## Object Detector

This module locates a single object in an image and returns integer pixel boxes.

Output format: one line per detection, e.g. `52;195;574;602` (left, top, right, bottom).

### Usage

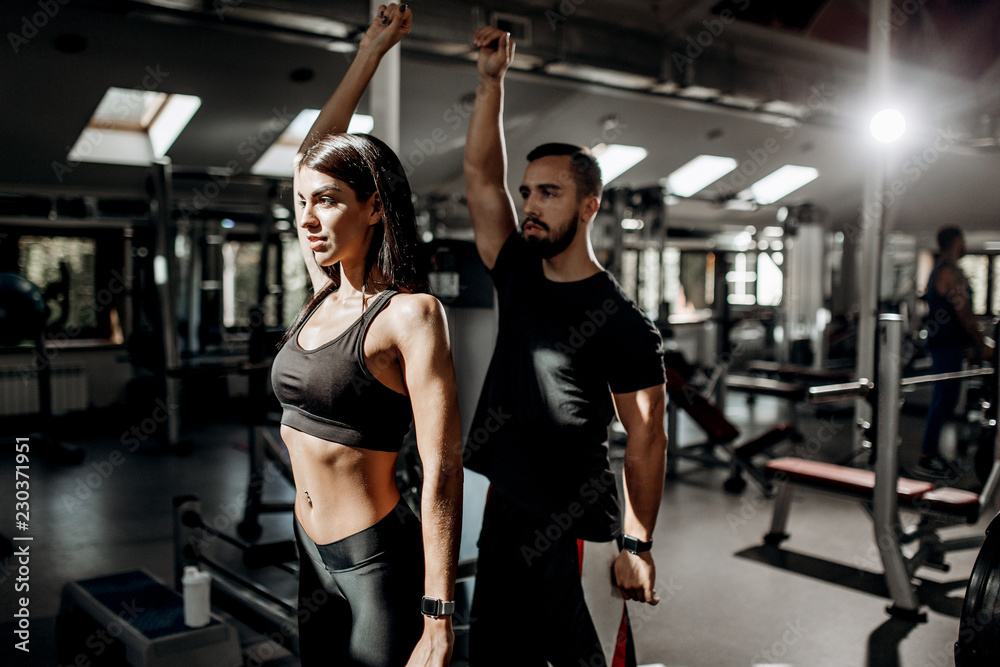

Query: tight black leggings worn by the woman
295;499;424;667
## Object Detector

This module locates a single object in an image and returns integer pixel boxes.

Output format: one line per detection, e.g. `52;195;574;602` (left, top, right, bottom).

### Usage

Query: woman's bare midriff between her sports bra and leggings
281;426;399;544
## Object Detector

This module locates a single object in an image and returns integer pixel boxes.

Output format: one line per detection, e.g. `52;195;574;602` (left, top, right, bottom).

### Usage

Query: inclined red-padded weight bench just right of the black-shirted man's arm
666;366;795;497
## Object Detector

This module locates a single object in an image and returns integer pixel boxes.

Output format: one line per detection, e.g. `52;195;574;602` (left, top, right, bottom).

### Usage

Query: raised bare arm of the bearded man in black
465;27;517;269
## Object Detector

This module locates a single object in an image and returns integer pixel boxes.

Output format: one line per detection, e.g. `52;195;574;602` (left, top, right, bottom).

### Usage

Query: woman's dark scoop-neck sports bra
271;290;413;452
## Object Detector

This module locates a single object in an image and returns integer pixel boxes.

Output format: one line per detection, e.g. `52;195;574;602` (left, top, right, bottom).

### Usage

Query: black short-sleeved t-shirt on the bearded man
465;232;664;541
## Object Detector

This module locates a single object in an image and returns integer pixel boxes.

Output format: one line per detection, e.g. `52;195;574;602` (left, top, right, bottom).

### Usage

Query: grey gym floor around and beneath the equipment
0;394;996;667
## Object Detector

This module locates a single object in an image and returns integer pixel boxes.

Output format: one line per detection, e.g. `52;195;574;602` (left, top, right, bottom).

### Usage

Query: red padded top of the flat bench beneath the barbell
765;457;979;523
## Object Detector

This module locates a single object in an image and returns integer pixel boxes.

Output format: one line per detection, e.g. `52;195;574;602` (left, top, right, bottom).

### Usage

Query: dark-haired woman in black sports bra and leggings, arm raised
272;5;462;667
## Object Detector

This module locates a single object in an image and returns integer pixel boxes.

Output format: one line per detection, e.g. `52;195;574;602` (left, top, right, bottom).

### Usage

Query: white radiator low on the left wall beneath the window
0;366;89;417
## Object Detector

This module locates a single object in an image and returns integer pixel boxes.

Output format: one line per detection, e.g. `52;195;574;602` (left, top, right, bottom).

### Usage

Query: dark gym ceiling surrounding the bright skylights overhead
0;0;1000;245
